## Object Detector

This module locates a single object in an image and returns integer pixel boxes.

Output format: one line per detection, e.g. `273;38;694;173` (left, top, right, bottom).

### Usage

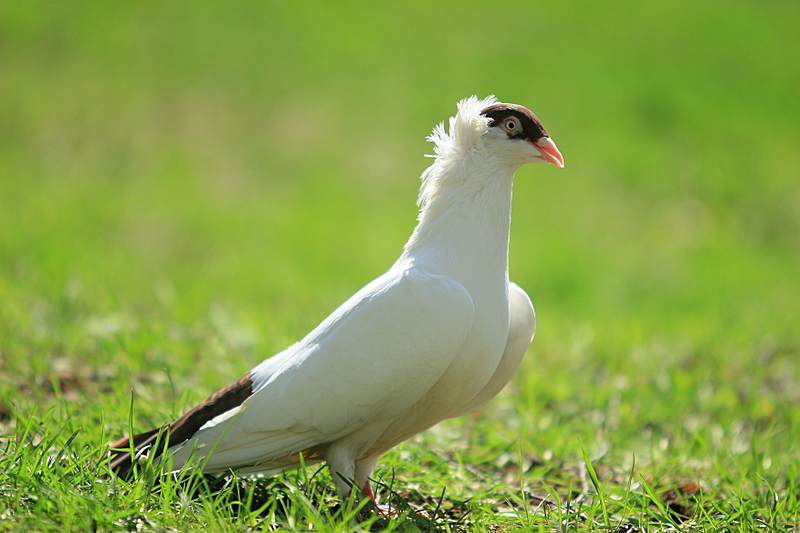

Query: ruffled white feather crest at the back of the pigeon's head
417;95;497;206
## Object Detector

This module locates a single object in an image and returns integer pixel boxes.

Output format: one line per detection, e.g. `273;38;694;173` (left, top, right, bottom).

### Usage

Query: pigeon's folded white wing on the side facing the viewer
169;269;474;471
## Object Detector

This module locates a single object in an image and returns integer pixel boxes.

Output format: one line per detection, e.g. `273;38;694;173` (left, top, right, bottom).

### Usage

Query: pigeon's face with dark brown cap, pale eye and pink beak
480;103;564;168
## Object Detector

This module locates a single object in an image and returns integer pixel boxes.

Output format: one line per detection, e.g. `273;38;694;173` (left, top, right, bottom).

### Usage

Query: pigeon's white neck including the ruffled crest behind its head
400;97;517;276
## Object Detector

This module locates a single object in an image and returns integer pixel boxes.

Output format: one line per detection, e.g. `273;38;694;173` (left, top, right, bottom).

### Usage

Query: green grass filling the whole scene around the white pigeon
0;0;800;533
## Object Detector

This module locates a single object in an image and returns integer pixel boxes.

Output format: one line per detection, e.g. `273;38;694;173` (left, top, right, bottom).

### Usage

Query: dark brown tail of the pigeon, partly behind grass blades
108;373;253;479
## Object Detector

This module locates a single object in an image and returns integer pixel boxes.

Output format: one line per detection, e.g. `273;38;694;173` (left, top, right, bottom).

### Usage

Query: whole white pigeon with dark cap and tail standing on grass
110;96;564;498
